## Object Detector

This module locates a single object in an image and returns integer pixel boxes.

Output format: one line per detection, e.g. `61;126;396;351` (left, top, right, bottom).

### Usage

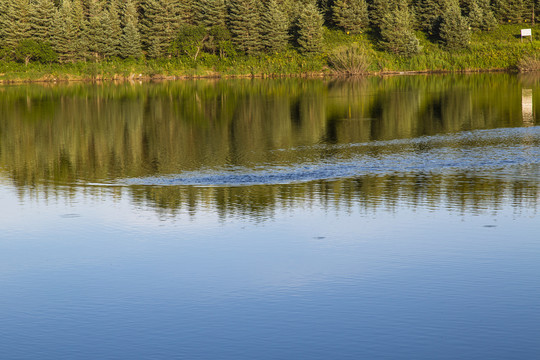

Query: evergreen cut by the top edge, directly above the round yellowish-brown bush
332;0;369;34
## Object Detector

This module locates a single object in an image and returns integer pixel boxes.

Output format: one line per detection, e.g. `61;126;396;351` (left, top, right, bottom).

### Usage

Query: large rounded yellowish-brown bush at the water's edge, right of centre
328;44;371;76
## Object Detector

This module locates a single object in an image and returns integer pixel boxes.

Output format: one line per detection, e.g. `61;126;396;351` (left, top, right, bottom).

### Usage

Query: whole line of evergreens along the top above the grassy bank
0;0;540;63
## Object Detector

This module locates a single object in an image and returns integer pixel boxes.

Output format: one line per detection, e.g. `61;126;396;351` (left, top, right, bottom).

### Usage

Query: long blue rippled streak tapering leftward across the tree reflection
121;127;540;186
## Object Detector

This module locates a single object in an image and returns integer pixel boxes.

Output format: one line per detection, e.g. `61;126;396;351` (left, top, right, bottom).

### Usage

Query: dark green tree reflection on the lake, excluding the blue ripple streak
0;74;540;217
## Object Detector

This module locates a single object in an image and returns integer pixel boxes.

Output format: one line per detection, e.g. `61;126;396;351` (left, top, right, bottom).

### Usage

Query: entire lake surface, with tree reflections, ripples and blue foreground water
0;74;540;360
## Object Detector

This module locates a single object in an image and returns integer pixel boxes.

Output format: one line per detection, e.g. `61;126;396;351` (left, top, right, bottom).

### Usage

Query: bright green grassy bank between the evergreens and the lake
0;24;540;82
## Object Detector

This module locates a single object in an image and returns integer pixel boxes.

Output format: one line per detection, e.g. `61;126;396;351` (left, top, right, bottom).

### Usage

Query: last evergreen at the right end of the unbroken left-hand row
297;3;324;53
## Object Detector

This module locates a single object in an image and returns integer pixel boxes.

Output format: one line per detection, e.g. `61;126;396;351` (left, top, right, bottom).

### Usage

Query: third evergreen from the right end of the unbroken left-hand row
228;0;261;55
